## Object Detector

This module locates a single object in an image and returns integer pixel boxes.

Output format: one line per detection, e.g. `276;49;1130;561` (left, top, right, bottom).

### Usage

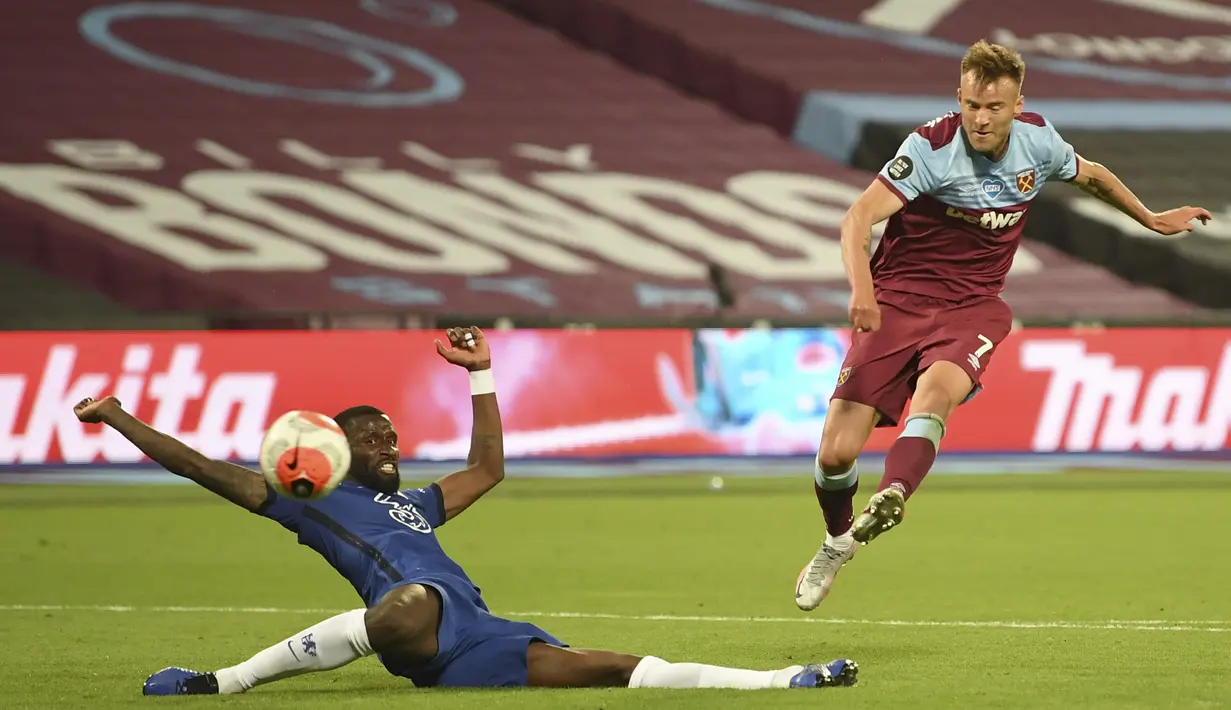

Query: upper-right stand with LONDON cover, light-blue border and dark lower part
491;0;1231;308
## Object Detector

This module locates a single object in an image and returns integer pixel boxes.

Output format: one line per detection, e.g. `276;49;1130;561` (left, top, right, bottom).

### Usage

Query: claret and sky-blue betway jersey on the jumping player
872;113;1077;301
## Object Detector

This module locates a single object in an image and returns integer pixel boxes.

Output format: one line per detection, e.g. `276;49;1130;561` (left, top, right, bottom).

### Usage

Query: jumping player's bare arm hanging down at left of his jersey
842;177;904;331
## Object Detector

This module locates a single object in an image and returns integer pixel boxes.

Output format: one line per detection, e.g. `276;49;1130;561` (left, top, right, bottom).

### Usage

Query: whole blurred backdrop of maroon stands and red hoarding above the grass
0;0;1231;480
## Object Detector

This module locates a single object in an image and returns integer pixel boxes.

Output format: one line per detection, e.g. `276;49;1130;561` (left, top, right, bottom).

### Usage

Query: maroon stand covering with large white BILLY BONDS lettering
0;0;1195;320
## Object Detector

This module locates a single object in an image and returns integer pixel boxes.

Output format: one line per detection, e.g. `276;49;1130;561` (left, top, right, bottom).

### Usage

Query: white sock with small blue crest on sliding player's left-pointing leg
214;609;372;694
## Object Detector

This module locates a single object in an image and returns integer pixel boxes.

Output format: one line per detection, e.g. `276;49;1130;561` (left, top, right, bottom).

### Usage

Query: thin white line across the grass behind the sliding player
0;604;1231;632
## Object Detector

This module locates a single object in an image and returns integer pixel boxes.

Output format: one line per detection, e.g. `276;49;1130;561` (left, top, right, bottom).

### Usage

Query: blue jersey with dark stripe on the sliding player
257;481;486;609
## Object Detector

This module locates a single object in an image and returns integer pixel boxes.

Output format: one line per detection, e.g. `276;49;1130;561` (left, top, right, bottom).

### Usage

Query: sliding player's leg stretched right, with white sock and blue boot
526;644;859;690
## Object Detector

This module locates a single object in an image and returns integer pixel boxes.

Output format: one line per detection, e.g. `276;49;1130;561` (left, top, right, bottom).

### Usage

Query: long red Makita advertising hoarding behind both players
0;329;1231;465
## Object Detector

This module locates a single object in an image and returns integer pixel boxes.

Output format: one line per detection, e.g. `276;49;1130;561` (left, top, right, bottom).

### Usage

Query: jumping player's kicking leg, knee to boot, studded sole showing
852;361;974;545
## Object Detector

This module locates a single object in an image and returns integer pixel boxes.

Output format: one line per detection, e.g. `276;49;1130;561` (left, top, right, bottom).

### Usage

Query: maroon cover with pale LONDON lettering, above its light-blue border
492;0;1231;130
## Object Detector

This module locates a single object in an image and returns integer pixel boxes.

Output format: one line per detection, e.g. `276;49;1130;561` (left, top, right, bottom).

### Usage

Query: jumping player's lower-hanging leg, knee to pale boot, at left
795;399;880;612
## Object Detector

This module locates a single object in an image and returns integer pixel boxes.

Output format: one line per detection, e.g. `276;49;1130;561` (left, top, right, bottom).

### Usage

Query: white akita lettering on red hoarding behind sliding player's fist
0;343;277;464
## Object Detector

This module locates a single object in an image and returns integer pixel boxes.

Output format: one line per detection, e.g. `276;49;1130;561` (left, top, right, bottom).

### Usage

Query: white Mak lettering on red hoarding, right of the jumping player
1022;340;1231;452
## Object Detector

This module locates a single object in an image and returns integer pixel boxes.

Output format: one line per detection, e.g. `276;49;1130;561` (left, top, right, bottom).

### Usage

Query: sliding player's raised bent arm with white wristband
436;327;505;521
